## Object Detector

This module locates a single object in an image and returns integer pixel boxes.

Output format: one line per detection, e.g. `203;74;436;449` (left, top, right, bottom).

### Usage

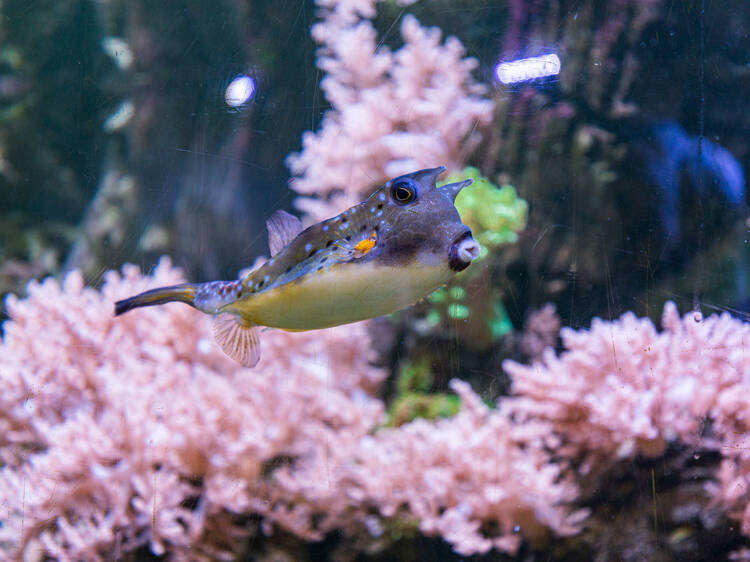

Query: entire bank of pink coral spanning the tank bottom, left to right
7;261;750;560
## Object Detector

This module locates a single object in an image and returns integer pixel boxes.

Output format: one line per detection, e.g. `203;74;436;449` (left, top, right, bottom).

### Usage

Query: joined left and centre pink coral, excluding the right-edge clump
0;261;580;560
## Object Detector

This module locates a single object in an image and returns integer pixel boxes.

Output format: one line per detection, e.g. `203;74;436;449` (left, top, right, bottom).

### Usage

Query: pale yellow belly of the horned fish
226;261;454;330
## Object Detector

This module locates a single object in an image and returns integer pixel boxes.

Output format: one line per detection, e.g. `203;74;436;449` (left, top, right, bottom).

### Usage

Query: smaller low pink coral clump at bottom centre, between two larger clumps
320;380;586;555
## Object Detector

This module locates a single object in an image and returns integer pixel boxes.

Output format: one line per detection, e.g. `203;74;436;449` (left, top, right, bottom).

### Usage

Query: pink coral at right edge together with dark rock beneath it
503;303;750;560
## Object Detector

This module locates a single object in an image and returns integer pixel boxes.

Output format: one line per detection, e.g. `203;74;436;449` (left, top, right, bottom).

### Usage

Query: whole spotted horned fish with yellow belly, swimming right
115;166;480;367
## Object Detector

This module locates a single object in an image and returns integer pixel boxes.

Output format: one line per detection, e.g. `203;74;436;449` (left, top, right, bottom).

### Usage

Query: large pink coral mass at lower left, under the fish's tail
0;262;383;559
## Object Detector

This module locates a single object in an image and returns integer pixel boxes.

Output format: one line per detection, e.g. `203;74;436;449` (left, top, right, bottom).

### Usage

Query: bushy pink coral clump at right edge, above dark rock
503;303;750;471
